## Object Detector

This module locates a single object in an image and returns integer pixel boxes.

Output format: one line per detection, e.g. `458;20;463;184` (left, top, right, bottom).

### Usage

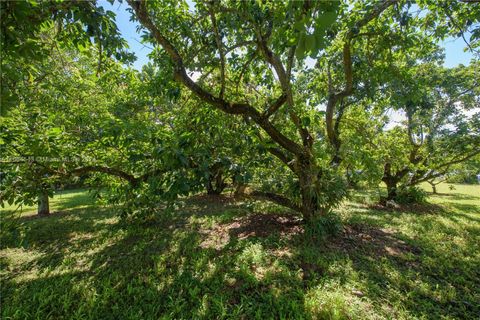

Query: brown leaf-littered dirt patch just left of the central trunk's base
200;213;303;249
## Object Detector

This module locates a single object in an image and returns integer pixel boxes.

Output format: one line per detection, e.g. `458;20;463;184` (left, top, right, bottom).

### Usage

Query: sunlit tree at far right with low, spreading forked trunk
342;63;480;200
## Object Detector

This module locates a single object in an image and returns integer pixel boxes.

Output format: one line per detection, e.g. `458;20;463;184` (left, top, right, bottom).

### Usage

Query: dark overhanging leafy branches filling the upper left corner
0;1;135;114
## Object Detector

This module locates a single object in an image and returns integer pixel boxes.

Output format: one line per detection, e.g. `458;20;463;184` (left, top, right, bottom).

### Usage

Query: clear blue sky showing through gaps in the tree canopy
99;0;472;70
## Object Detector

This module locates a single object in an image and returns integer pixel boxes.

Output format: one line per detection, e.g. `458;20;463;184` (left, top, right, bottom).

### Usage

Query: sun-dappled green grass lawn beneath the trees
0;185;480;319
